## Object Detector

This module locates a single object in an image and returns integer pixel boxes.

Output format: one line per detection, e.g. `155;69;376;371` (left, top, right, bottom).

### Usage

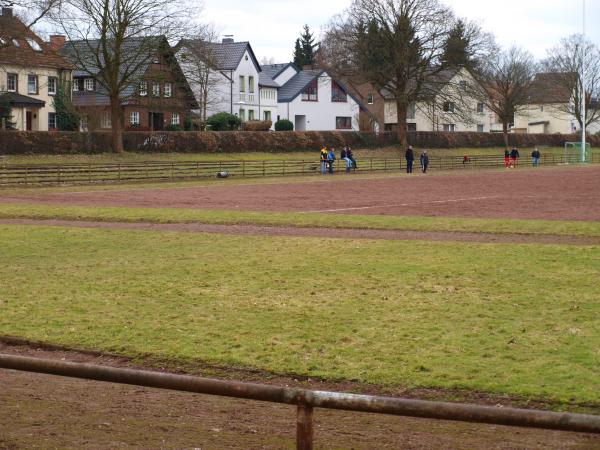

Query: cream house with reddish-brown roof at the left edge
0;8;72;131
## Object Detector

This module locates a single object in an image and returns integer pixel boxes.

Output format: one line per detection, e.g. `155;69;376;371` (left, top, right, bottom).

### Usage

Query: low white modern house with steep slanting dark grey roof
263;63;364;131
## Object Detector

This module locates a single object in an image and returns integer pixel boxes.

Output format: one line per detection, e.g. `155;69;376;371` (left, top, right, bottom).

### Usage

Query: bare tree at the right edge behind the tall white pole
542;34;600;130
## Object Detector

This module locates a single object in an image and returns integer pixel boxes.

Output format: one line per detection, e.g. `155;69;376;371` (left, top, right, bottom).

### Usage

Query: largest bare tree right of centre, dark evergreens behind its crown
321;0;490;147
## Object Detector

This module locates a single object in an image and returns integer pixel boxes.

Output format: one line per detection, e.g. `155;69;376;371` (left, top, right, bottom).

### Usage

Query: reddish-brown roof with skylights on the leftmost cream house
0;11;72;70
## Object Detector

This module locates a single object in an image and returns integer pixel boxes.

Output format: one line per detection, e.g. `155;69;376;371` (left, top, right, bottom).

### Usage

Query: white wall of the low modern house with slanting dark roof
278;75;360;131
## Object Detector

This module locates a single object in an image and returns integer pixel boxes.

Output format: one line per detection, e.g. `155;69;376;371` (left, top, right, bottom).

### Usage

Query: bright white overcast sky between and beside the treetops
202;0;600;62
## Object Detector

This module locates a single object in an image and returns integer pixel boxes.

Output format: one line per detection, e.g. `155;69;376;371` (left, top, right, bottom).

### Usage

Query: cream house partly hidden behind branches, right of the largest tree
381;68;497;133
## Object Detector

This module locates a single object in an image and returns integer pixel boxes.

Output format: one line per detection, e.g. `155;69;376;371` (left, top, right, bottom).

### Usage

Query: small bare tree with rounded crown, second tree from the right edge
469;47;537;147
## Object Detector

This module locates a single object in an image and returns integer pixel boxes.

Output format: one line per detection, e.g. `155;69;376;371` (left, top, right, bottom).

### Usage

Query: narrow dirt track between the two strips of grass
0;219;600;245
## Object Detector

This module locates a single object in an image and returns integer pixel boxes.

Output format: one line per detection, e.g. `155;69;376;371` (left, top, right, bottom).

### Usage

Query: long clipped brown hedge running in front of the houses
0;131;600;154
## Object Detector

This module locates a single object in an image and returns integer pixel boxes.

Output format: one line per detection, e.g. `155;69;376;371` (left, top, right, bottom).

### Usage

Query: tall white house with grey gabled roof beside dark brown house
177;37;279;122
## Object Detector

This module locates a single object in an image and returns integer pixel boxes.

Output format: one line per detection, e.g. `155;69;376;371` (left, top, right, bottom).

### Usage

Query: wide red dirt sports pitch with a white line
0;166;600;220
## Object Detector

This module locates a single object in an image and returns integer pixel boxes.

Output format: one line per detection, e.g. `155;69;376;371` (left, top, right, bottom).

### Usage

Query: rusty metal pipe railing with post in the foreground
0;354;600;450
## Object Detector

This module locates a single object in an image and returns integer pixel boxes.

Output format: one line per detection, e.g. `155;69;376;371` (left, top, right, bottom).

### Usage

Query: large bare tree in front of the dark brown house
54;0;199;152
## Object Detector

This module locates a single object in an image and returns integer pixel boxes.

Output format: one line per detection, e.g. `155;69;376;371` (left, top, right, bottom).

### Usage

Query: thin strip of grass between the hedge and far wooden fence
0;146;564;165
